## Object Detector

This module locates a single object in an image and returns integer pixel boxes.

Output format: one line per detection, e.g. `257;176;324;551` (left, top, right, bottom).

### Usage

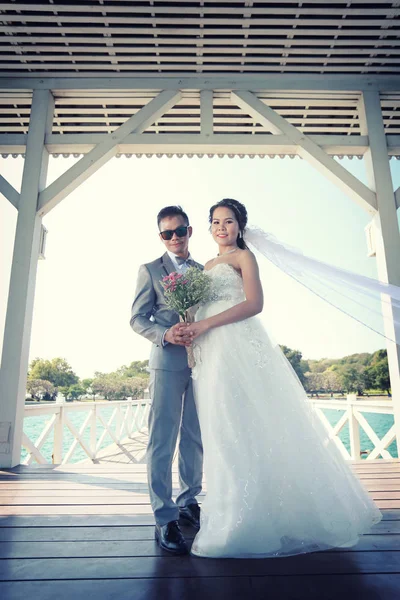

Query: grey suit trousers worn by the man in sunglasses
147;367;203;525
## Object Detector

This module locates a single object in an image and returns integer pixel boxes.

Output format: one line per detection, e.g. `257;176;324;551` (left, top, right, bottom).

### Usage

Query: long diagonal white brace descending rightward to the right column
232;91;376;214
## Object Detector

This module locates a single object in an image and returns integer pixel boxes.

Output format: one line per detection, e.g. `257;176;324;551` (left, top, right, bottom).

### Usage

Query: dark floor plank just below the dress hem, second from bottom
0;551;400;581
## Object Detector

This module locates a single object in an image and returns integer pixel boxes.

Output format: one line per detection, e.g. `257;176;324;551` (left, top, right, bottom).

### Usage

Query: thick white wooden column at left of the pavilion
0;90;54;468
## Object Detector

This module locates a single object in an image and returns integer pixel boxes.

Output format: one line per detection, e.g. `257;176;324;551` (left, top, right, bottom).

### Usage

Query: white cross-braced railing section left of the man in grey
21;400;151;465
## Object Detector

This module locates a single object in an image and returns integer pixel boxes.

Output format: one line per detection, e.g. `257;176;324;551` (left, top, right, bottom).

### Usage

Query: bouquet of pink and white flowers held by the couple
161;267;211;368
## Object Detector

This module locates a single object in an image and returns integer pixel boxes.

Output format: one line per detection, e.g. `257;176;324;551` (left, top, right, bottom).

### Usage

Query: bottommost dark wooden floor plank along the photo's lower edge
0;574;400;600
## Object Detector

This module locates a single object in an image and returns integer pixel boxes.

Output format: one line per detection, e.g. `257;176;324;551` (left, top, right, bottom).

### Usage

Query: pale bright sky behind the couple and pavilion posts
0;157;400;378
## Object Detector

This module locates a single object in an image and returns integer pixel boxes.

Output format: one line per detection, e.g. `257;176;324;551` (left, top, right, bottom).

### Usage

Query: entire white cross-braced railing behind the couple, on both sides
22;394;396;465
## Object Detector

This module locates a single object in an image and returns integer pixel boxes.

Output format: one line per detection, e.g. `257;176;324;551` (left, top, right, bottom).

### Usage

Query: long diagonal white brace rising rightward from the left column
38;91;181;216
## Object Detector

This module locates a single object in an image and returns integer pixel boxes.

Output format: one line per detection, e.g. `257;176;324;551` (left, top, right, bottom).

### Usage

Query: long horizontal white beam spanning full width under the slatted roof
0;74;400;92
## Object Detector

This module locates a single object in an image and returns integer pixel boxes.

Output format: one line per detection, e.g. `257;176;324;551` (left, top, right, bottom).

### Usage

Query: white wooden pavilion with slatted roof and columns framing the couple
0;0;400;468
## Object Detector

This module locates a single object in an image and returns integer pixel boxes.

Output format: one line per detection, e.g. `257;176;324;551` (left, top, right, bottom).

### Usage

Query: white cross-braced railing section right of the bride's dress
310;394;396;460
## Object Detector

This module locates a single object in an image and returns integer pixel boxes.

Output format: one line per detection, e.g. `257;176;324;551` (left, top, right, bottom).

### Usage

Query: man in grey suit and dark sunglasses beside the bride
130;206;203;554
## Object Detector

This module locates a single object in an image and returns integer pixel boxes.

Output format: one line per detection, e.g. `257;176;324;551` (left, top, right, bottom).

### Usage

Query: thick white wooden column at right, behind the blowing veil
359;91;400;450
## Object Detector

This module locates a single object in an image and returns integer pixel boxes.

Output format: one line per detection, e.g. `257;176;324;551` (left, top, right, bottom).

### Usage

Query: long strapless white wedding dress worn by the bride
192;263;382;558
